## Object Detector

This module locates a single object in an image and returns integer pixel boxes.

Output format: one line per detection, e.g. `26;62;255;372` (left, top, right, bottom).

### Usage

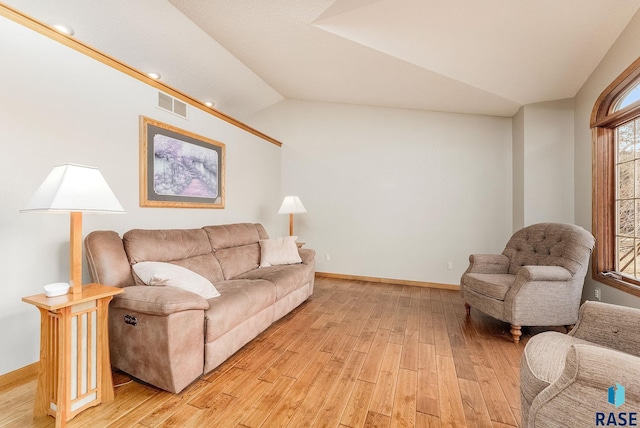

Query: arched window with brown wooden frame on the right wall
591;58;640;296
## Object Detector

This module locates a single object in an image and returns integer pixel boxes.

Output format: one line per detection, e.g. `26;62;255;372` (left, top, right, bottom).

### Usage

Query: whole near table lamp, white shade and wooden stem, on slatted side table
20;164;124;295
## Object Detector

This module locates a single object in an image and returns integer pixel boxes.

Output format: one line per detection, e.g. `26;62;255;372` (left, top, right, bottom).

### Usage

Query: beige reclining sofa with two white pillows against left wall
85;223;315;393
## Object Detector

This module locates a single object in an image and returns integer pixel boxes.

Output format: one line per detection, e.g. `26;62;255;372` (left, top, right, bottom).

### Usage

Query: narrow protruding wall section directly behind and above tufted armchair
513;99;574;230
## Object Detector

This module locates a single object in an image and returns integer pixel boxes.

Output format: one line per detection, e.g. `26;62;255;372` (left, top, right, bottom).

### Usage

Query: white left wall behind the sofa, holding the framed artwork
0;17;286;374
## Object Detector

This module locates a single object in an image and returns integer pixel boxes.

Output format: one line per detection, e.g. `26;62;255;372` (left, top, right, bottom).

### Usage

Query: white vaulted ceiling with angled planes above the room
4;0;640;120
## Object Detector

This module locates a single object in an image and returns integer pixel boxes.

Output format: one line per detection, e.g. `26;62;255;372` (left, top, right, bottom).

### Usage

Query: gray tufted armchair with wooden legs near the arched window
460;223;595;343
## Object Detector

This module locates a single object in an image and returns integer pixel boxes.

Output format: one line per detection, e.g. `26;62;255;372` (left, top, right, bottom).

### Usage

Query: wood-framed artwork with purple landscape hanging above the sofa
140;116;225;208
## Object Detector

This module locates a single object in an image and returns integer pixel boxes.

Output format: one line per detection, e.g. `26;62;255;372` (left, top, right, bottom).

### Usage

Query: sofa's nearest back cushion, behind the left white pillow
122;229;224;285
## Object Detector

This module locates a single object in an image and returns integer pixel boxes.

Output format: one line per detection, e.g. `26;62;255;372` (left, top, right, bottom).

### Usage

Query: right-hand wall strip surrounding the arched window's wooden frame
574;7;640;307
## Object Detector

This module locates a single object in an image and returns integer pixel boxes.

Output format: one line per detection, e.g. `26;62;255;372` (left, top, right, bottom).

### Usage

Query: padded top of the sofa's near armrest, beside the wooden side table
111;285;209;316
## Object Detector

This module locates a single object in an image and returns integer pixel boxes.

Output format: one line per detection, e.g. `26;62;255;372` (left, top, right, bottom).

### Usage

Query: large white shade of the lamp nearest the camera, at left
20;164;124;213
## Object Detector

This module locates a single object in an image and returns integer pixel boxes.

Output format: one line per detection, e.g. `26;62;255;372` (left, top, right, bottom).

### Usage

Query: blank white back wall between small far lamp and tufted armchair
251;100;512;284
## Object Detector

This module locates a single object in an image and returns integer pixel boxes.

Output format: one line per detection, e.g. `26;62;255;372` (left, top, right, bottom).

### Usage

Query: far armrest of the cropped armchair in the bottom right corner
570;301;640;356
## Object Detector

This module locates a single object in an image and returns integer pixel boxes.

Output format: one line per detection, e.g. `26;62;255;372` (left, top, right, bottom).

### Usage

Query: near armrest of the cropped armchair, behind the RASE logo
526;344;640;427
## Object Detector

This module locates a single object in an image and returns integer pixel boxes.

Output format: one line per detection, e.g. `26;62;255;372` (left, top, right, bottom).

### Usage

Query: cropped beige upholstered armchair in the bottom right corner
520;301;640;428
